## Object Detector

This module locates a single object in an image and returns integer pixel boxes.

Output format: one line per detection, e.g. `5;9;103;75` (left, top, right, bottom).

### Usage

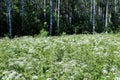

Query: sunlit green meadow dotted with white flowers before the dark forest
0;34;120;80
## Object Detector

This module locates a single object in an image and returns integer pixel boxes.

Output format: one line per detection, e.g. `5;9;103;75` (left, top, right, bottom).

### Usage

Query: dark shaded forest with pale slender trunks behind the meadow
0;0;120;37
